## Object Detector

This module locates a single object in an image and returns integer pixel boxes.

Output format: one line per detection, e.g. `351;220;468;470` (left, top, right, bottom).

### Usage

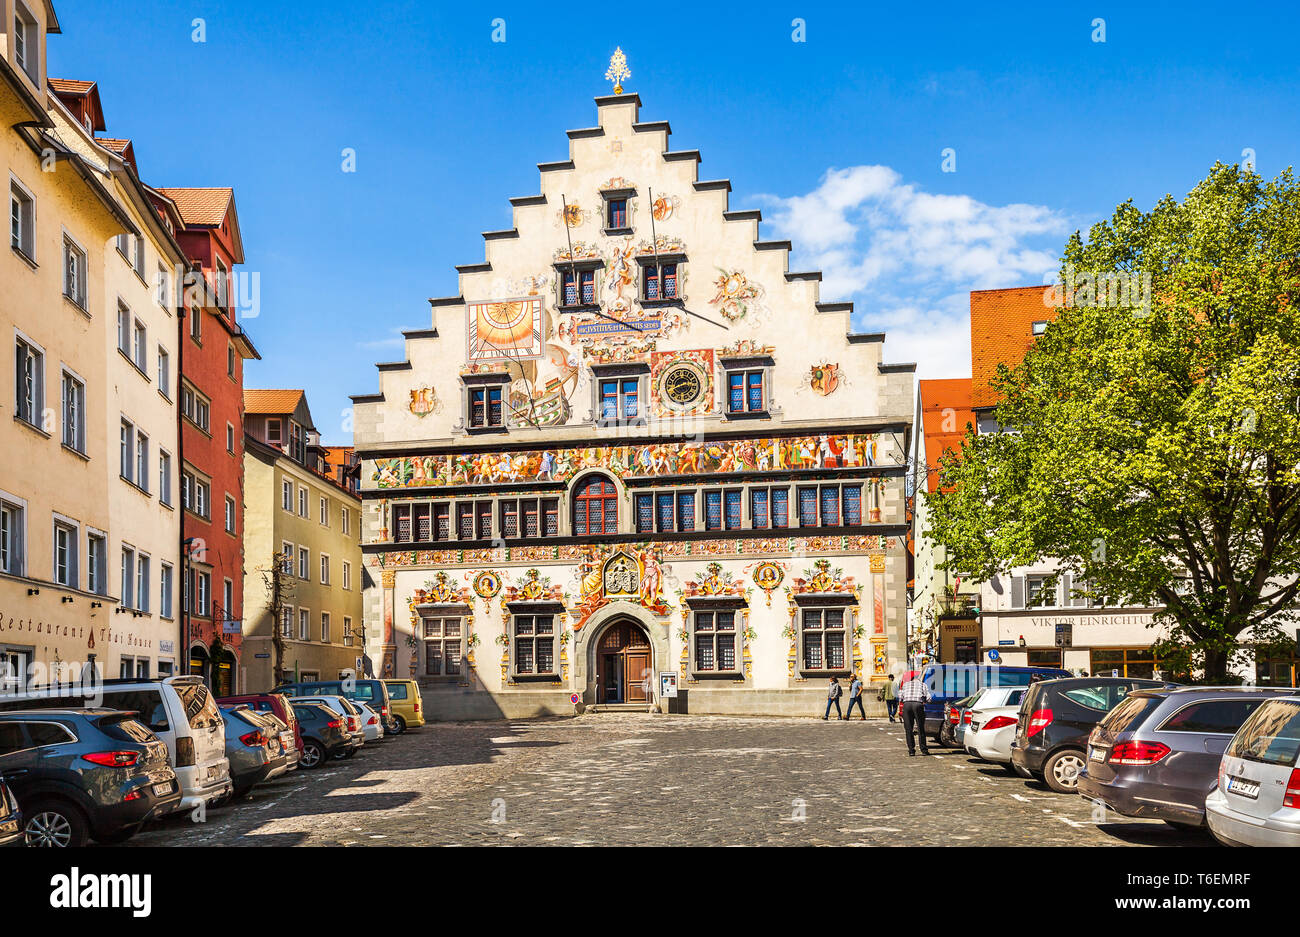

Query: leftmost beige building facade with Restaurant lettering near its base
0;0;165;682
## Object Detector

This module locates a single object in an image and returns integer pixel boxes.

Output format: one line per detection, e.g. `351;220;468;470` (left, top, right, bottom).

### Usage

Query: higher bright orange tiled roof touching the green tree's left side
970;286;1057;409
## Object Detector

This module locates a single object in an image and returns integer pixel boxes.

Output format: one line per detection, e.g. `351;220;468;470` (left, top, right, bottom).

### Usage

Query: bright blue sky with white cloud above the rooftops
49;0;1300;443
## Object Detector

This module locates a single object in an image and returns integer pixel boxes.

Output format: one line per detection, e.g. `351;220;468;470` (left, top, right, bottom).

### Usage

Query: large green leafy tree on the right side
930;164;1300;682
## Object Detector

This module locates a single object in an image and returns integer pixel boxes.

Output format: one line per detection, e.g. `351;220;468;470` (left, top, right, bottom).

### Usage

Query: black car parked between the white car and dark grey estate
1011;677;1178;794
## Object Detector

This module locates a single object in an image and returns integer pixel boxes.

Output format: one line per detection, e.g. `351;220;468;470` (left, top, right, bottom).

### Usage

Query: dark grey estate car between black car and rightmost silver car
1079;686;1295;828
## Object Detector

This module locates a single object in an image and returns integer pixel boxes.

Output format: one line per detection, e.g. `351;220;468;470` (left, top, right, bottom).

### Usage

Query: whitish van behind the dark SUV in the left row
0;676;234;810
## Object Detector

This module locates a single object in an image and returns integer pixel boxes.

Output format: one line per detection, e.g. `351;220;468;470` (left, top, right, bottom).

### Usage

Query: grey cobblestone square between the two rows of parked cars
130;713;1213;846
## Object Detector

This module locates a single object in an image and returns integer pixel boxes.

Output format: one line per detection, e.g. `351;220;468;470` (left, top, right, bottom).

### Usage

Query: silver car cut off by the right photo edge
1205;695;1300;846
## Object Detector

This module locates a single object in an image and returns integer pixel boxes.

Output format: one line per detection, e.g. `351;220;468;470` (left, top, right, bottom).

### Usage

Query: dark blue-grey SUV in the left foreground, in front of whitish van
0;708;182;847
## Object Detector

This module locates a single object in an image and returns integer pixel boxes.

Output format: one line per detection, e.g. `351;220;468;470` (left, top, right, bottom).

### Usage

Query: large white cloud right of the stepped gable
759;166;1067;377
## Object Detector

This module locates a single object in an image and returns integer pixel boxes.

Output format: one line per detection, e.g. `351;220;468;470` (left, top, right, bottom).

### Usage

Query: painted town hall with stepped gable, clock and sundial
354;88;914;719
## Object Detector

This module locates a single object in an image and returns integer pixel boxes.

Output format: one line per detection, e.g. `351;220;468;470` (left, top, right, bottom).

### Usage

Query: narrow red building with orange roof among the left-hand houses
159;188;260;695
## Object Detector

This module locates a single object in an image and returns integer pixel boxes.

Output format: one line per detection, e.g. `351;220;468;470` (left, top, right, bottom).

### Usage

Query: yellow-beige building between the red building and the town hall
241;390;364;691
